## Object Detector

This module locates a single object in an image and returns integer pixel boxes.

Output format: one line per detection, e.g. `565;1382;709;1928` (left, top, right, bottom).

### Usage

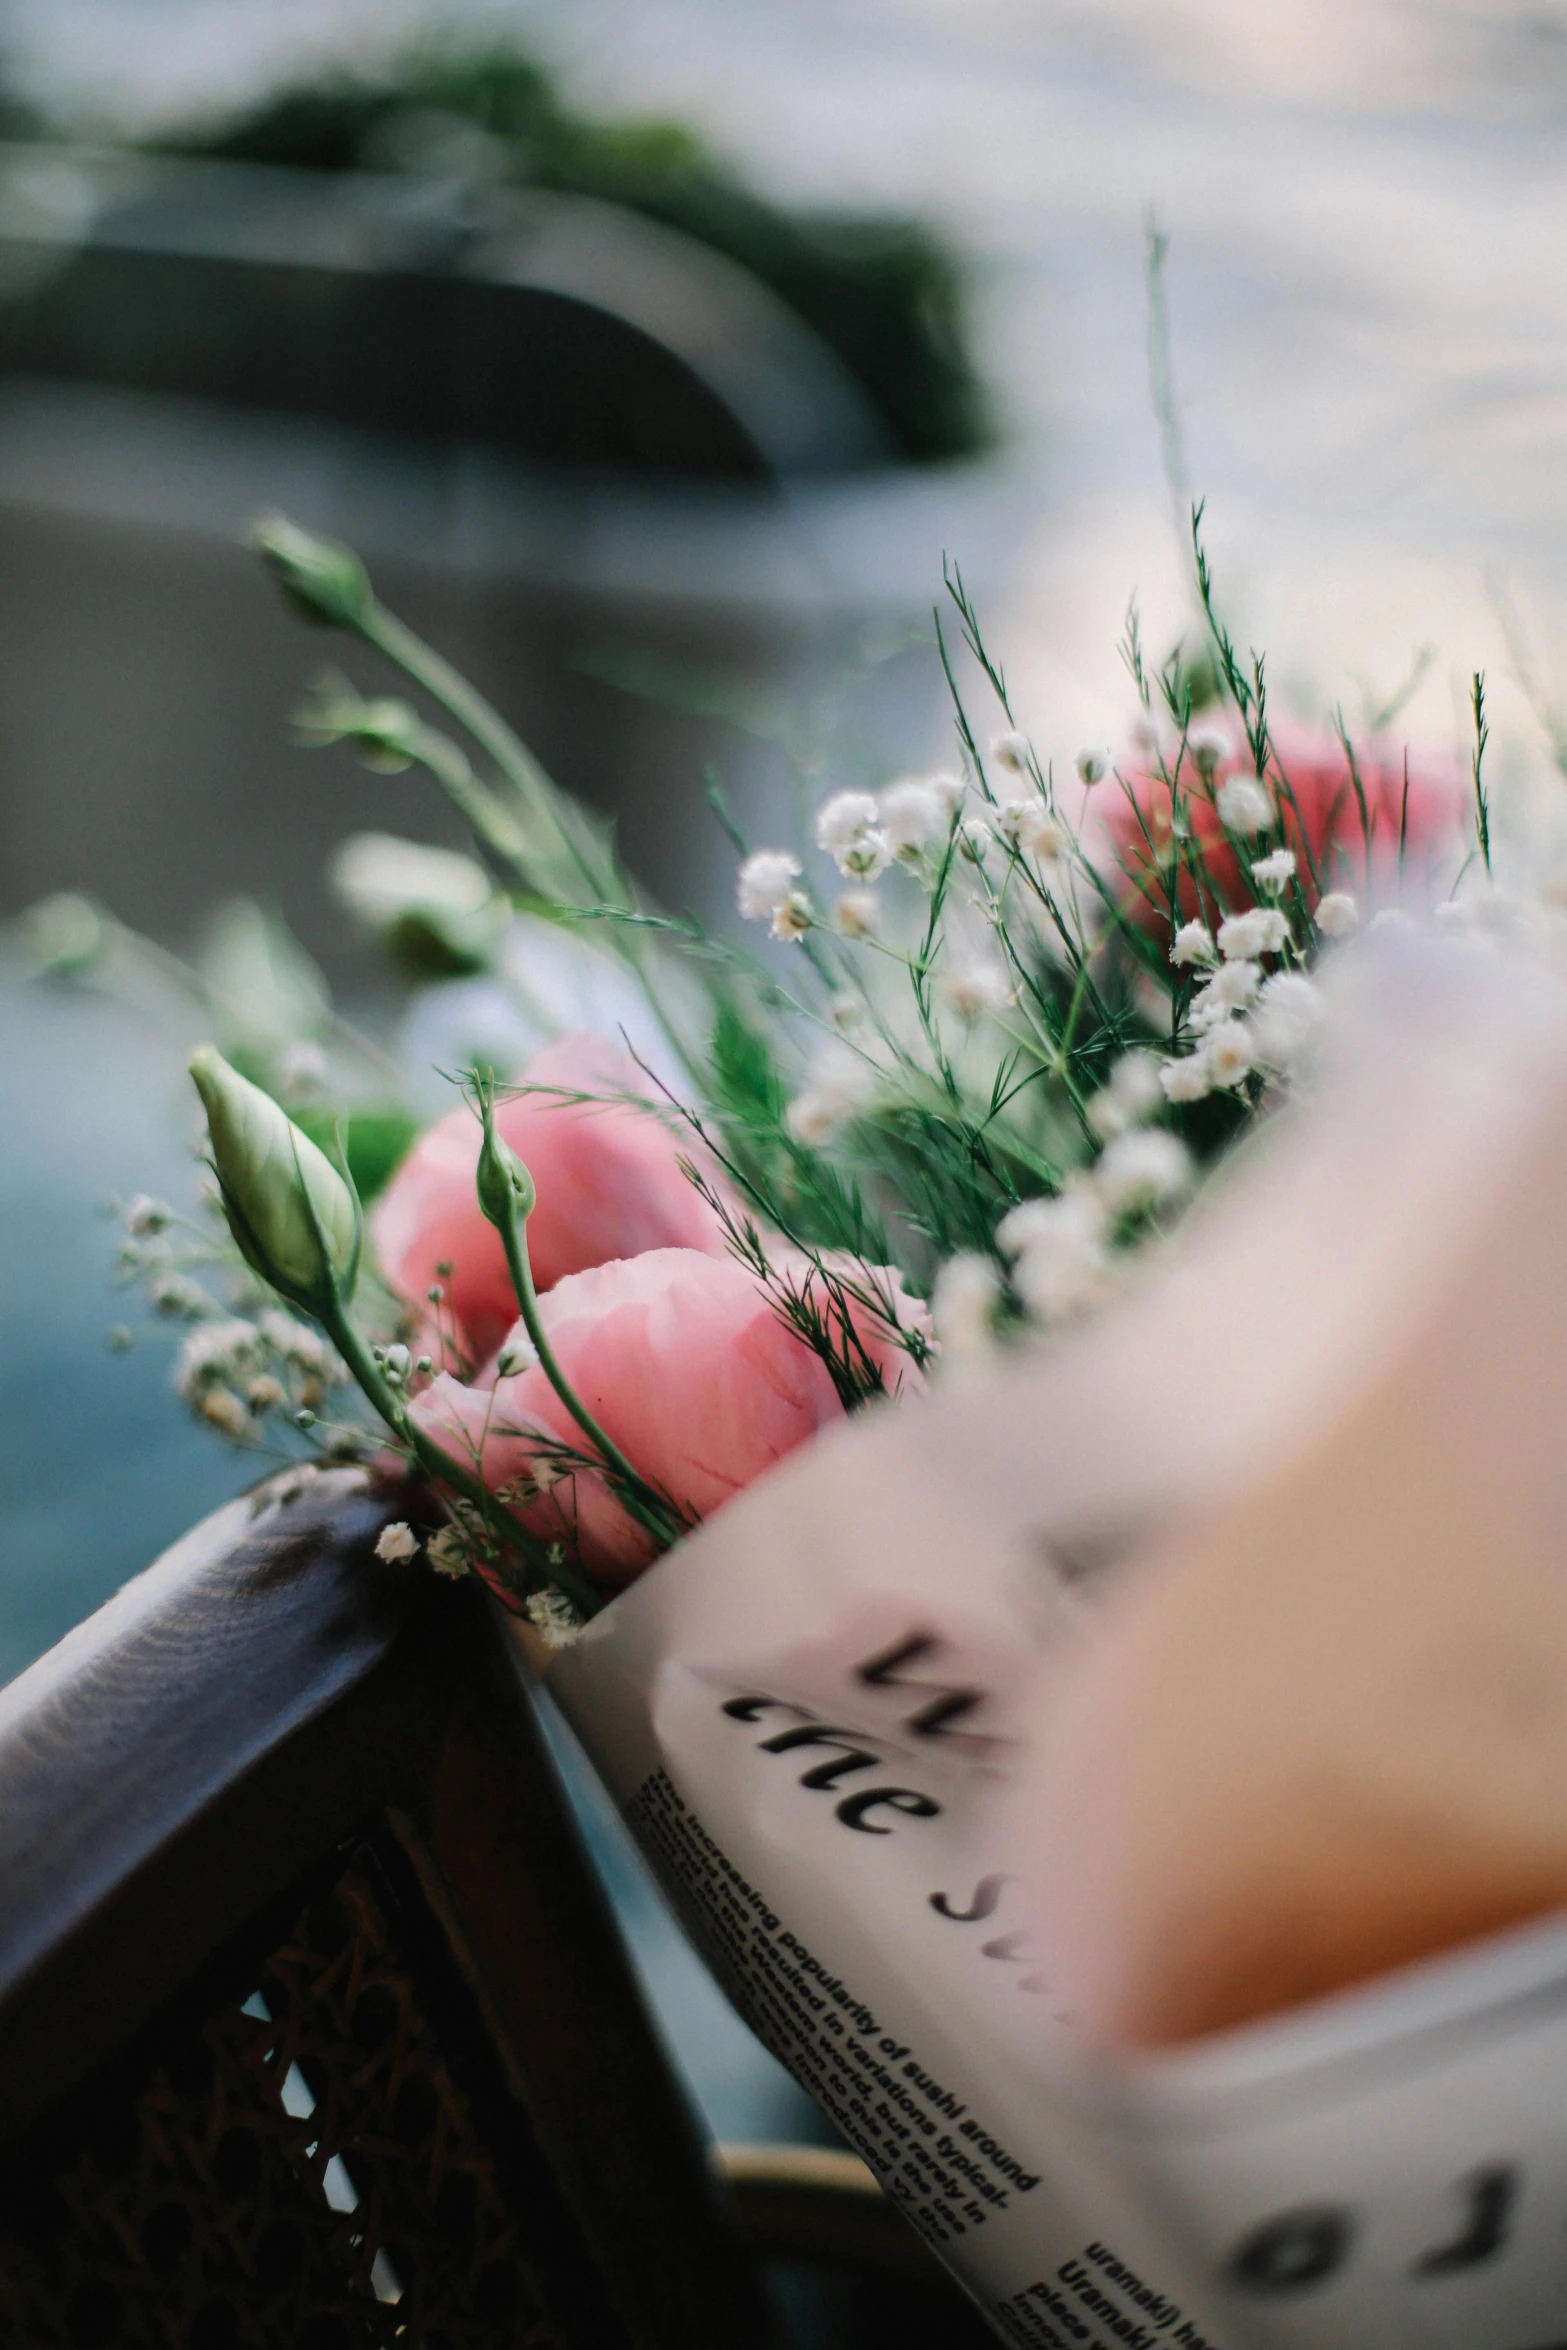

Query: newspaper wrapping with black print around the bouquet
533;954;1567;2350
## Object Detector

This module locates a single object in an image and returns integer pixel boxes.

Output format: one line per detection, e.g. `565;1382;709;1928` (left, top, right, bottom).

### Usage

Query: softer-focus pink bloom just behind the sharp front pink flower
371;1036;724;1356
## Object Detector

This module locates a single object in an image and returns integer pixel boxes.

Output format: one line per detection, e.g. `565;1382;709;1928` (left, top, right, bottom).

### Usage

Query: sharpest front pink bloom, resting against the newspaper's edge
413;1248;923;1584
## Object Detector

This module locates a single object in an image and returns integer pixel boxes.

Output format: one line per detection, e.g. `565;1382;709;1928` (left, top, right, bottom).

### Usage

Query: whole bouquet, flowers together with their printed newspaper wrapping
35;510;1567;2350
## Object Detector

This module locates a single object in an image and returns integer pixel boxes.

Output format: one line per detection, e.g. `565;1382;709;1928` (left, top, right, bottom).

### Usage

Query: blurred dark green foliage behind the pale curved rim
159;47;987;463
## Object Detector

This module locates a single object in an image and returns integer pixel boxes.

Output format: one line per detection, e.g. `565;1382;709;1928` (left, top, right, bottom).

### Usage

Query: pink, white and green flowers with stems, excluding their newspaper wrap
55;522;1485;1640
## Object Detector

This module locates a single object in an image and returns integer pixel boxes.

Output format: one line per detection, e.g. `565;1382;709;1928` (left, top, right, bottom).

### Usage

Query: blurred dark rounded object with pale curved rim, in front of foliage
0;148;890;479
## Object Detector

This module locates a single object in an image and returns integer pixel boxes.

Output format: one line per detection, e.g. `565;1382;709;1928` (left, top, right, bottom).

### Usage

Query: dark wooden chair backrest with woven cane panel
0;1471;771;2350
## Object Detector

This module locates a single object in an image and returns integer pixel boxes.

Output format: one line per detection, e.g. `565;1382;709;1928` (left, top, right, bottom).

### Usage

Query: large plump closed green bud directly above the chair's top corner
190;1043;359;1318
